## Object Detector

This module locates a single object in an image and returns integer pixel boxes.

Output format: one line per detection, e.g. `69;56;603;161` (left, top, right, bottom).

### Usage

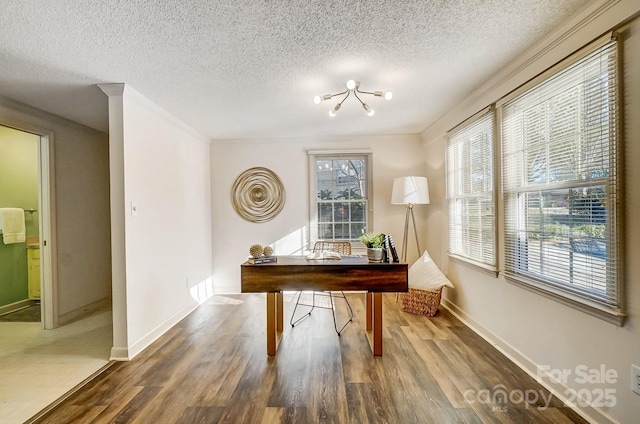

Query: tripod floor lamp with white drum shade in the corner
391;177;429;262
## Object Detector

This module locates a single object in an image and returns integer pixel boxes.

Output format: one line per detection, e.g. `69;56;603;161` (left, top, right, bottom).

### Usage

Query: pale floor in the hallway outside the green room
0;311;113;424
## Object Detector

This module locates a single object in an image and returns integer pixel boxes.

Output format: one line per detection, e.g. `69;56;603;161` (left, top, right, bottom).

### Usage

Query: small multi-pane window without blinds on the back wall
309;152;372;244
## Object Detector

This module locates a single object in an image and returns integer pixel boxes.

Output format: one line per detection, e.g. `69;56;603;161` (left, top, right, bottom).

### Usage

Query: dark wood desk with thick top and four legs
240;256;408;356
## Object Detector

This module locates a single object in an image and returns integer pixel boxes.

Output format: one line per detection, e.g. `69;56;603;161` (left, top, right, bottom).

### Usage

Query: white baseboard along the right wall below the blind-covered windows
440;298;620;424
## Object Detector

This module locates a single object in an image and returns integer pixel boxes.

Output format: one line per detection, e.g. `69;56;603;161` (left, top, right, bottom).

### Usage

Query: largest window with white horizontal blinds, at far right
501;41;623;323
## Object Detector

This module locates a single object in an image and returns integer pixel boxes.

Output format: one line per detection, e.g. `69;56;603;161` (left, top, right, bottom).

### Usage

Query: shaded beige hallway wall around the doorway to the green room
0;99;111;324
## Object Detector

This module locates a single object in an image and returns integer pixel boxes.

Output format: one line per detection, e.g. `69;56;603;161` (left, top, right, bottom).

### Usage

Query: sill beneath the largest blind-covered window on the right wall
503;272;627;327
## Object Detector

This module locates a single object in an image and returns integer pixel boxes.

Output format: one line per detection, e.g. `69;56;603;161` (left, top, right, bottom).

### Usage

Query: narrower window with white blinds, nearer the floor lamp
446;109;496;270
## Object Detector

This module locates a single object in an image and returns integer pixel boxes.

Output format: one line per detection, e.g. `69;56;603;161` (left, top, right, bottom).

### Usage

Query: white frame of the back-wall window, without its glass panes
307;150;373;249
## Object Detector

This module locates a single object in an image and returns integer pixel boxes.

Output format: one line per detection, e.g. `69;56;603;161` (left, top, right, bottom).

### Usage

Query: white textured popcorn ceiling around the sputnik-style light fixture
0;0;587;139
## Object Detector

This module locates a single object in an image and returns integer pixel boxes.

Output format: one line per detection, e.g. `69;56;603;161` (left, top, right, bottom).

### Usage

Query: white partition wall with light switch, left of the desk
101;84;211;359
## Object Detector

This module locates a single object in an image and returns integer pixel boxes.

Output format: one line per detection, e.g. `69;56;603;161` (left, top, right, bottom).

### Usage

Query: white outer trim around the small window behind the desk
306;149;374;250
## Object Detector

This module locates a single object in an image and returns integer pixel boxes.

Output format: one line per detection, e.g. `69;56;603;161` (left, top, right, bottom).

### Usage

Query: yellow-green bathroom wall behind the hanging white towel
0;126;39;306
